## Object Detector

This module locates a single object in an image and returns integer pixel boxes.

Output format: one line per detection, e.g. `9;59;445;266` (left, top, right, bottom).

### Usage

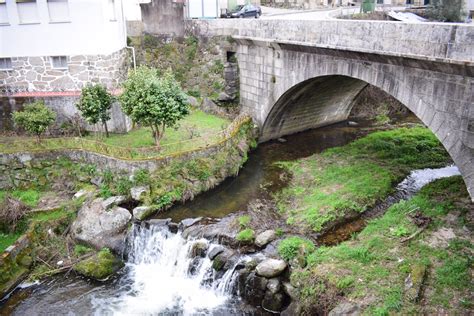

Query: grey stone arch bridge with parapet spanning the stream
187;20;474;201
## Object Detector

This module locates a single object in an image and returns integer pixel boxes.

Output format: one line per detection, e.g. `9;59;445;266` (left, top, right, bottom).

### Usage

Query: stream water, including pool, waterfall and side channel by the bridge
0;122;459;315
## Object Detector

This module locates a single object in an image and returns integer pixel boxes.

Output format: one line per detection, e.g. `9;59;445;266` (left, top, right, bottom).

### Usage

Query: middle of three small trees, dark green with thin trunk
76;84;114;137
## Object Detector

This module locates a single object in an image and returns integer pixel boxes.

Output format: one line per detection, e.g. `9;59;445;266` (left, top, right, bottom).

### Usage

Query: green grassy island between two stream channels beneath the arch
277;127;450;233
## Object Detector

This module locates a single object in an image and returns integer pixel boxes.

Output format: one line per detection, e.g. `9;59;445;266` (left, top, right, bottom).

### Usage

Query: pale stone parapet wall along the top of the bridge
185;19;474;64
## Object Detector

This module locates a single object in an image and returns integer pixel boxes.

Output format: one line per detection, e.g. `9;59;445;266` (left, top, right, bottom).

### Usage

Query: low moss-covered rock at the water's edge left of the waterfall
73;248;123;281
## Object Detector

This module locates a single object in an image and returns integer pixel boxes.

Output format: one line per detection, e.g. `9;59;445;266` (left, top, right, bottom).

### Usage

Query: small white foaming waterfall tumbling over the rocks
93;225;241;315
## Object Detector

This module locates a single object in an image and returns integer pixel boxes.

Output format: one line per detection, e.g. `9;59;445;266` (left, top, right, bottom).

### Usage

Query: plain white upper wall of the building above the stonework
0;0;126;57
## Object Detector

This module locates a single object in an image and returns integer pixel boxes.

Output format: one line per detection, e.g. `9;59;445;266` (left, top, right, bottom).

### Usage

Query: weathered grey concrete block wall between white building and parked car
140;0;184;37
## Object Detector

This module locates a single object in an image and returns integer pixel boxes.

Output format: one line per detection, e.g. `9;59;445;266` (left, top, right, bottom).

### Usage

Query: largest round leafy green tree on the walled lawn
120;67;189;146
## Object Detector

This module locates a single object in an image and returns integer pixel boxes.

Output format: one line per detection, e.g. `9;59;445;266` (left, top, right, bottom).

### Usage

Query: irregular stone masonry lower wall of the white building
0;48;128;95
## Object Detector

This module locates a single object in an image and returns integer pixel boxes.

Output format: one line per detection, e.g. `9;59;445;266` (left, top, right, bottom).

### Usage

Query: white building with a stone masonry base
0;0;127;95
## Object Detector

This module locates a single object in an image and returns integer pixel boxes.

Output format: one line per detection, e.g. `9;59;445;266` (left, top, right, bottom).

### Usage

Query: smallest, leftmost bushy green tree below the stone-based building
12;101;56;142
